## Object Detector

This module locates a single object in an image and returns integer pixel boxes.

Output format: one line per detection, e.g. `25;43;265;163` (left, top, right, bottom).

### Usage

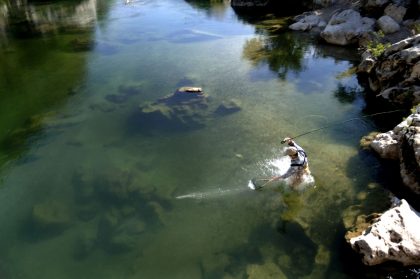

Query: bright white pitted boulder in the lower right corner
349;200;420;266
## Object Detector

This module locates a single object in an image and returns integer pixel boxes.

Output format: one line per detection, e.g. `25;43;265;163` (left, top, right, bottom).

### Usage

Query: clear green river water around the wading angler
0;0;404;279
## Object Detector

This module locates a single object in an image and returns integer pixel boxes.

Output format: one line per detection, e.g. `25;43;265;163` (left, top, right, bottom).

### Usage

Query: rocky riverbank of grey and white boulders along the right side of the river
231;0;420;272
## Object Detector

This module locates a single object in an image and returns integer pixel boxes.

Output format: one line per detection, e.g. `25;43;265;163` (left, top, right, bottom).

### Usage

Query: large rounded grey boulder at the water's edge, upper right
320;9;375;46
